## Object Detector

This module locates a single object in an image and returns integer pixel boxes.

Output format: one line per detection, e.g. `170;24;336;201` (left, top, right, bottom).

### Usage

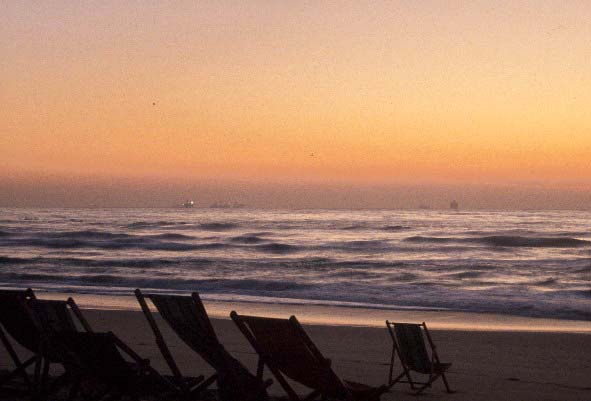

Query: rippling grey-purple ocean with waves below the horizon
0;208;591;321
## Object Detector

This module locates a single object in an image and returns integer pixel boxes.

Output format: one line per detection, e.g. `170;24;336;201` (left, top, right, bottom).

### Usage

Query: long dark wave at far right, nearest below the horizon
403;235;591;248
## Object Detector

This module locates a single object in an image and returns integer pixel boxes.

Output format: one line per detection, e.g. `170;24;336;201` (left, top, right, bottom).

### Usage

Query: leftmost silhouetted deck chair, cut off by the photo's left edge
0;288;39;389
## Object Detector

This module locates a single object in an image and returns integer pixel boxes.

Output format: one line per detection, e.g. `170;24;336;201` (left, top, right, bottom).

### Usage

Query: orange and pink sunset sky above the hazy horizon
0;0;591;208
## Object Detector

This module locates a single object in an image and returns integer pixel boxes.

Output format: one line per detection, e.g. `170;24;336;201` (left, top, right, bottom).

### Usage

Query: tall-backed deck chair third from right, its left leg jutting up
135;289;271;401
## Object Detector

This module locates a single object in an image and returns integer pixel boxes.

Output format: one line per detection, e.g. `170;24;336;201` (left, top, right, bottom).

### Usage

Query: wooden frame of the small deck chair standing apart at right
386;320;454;394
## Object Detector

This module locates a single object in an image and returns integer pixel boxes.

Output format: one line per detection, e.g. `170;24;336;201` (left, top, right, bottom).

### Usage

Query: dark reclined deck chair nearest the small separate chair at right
230;311;387;401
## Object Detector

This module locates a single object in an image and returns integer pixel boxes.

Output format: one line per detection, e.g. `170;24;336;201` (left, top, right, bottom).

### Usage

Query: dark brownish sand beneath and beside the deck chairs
1;304;591;401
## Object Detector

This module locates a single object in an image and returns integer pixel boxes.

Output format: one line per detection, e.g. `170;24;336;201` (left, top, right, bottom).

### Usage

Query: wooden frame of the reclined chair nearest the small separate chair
230;311;387;401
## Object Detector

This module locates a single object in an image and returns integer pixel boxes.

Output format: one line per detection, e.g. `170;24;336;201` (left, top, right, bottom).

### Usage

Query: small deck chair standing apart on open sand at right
386;320;453;394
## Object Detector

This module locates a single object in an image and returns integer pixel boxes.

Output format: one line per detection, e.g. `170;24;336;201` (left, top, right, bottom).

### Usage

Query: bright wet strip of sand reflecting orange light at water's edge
36;291;591;335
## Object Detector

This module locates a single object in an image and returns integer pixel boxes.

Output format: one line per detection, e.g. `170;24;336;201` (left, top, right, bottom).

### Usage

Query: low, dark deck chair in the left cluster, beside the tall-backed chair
48;331;170;401
